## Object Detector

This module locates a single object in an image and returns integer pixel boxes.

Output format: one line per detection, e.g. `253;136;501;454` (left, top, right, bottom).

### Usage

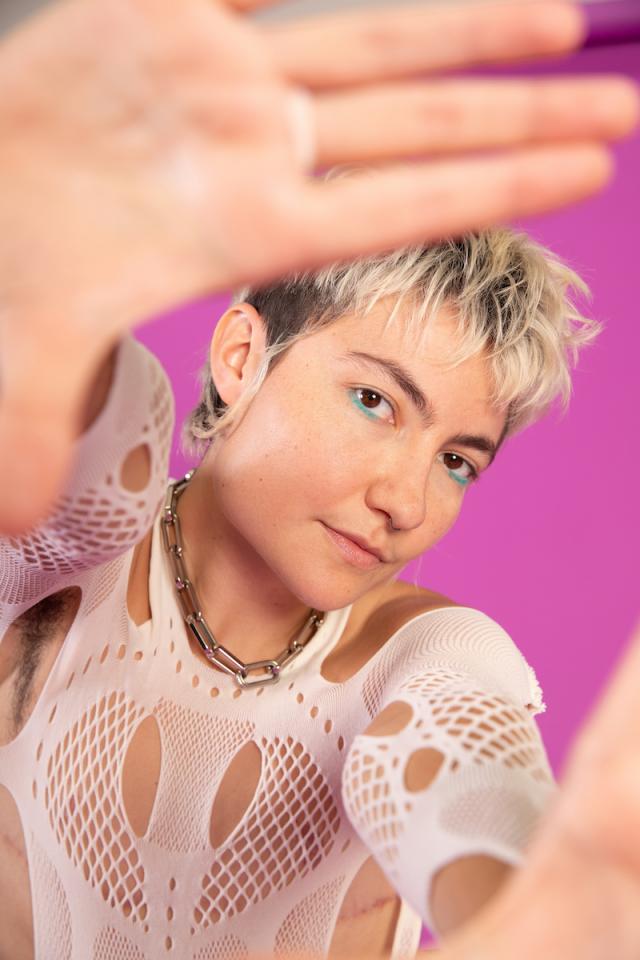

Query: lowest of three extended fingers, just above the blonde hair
258;144;611;272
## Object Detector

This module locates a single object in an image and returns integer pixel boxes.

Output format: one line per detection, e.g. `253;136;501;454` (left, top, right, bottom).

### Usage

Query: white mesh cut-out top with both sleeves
0;338;555;960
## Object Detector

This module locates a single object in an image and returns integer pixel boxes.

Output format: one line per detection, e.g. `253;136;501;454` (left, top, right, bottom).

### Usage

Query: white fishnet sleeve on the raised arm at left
0;337;174;620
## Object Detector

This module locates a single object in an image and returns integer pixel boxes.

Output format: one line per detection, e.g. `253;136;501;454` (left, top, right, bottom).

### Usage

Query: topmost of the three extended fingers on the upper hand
261;0;586;89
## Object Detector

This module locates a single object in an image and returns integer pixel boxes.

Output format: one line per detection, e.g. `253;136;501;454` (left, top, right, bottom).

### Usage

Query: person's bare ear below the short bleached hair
209;303;266;406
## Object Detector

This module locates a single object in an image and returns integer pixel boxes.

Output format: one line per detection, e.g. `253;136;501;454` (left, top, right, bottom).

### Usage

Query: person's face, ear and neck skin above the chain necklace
179;301;505;660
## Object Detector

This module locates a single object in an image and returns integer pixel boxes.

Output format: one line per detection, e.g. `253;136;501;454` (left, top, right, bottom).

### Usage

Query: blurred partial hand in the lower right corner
442;628;640;960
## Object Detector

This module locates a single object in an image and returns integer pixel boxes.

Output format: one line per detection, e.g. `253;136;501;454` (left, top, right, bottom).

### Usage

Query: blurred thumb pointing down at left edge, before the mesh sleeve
0;324;105;535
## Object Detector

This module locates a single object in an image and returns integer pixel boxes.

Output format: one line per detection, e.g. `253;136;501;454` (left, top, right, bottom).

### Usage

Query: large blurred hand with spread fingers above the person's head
0;0;637;533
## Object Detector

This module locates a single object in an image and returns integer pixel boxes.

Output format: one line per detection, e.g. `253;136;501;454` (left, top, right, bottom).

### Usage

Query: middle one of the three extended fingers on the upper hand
314;78;639;166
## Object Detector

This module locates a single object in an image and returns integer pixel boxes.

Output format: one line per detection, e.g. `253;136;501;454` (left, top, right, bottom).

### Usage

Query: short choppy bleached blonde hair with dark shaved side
182;227;600;455
